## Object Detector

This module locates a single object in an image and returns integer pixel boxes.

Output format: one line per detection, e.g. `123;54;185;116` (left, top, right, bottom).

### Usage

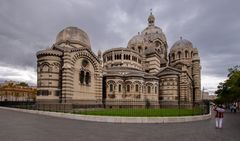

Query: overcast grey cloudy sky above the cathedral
0;0;240;91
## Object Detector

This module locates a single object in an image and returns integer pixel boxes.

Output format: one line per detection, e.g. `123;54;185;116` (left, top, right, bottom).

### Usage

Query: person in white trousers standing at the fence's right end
214;105;225;129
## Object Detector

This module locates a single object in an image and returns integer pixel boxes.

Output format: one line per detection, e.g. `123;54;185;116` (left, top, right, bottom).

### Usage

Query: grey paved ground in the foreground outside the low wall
0;109;240;141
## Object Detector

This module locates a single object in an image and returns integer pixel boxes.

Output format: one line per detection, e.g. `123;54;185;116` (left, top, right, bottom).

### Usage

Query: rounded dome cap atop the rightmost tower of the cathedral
171;38;193;51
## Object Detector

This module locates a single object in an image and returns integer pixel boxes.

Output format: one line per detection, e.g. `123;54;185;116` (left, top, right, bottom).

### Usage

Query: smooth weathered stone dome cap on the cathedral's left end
56;27;91;48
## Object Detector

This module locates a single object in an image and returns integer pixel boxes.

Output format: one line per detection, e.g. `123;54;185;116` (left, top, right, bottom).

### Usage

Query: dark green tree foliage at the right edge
215;65;240;103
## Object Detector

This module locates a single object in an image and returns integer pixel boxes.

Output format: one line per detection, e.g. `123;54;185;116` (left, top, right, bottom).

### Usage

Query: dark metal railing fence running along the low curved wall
0;100;209;116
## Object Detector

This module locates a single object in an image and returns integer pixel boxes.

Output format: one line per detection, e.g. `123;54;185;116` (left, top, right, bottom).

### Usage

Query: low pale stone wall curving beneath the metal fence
0;107;211;123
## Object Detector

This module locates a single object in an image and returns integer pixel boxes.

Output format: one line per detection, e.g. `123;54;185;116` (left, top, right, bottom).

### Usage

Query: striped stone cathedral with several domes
36;13;201;104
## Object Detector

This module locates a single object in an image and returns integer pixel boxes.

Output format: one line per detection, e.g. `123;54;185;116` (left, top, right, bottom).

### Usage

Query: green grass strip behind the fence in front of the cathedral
74;108;203;117
